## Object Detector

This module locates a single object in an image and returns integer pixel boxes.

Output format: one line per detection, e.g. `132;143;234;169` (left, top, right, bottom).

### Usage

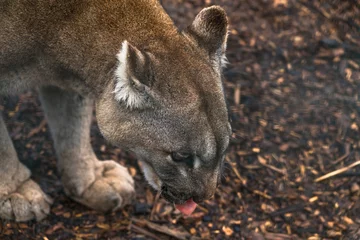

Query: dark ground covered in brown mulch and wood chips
0;0;360;240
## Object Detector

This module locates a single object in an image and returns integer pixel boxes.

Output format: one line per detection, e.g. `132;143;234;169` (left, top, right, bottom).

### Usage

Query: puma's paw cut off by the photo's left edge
0;179;53;222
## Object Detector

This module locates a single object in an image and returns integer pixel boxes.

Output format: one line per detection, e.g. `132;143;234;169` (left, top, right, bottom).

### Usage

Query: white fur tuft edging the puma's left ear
114;41;144;109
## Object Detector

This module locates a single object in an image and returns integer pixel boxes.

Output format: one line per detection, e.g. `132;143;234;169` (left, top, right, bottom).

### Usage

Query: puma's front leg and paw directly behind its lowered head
40;87;135;211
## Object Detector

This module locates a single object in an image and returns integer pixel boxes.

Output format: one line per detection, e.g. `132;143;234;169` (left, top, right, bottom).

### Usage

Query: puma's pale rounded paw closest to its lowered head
64;161;135;212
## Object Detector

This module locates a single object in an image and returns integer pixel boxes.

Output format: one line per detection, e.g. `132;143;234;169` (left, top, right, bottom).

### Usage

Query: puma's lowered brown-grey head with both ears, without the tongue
96;7;231;203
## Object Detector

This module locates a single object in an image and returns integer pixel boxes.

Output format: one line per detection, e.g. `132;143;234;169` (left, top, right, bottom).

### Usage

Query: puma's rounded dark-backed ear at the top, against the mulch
185;6;228;66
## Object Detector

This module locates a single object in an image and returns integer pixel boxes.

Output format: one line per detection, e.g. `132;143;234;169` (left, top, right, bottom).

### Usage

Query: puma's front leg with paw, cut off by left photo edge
0;116;52;222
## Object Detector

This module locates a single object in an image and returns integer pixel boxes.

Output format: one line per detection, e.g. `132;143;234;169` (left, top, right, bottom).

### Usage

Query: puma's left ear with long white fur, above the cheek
114;41;150;109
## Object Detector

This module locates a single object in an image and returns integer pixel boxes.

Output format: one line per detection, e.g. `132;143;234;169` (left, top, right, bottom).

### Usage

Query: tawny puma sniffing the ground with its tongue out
0;0;231;221
